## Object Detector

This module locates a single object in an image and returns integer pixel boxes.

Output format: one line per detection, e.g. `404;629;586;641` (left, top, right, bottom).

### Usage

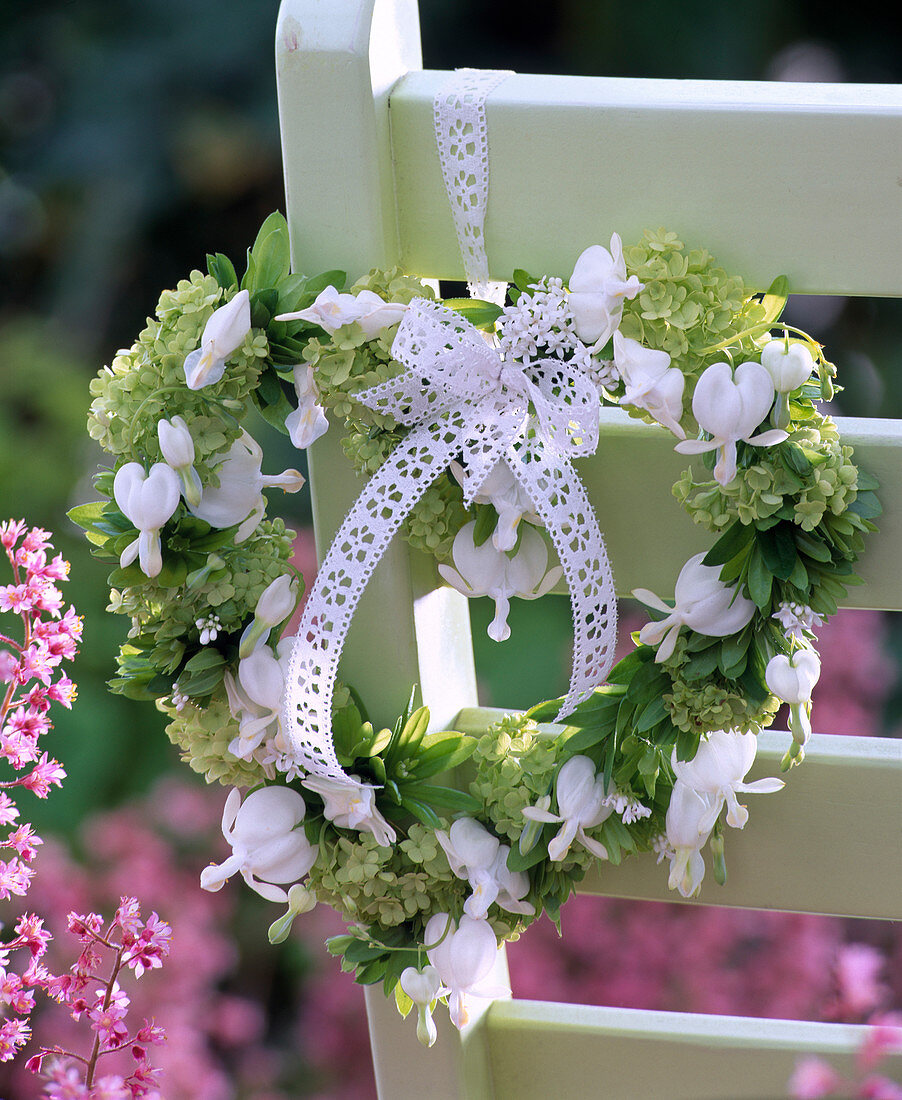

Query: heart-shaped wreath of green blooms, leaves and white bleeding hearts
72;215;879;1043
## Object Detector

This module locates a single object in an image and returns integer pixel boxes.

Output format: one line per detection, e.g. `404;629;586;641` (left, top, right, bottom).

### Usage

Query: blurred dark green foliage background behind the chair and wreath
0;0;902;831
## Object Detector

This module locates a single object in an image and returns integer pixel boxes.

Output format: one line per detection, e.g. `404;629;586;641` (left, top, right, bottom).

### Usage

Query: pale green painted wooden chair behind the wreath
276;0;902;1100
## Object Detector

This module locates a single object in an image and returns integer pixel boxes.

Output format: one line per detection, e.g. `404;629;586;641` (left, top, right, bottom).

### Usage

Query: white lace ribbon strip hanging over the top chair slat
432;68;512;305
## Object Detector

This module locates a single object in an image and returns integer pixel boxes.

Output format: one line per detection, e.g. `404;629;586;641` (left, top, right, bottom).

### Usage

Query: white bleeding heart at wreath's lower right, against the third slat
671;729;783;833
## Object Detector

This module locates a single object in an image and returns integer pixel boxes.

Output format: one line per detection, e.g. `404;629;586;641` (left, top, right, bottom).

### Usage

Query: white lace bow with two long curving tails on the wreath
283;298;617;778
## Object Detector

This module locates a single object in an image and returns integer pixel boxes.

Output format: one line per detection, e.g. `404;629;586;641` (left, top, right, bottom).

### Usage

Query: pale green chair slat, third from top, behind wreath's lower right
454;707;902;920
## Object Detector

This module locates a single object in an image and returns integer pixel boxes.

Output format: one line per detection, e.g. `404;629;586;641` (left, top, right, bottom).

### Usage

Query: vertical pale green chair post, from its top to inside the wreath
276;0;476;727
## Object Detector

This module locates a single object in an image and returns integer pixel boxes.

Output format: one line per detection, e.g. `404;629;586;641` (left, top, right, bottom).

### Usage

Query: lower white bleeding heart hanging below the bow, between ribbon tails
439;520;563;641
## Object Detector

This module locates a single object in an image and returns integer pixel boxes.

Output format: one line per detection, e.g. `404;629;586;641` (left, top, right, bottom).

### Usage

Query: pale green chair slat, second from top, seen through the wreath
576;408;902;611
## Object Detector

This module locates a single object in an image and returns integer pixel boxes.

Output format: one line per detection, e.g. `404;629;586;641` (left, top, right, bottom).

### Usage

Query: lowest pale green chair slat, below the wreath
483;1001;902;1100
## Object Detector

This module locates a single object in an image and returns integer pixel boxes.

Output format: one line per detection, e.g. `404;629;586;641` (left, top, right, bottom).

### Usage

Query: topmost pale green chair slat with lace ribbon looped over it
389;72;902;296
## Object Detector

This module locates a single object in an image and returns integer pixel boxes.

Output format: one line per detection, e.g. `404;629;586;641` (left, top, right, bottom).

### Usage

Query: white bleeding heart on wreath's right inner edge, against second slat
633;553;755;662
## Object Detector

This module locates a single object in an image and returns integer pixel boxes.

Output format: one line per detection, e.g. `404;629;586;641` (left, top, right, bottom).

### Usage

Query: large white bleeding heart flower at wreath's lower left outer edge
200;787;318;901
